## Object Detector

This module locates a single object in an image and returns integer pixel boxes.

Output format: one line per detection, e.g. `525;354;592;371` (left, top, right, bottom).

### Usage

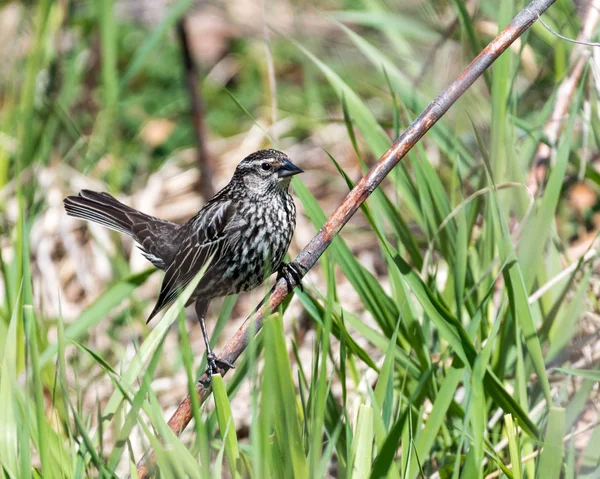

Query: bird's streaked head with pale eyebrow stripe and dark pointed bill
234;150;303;194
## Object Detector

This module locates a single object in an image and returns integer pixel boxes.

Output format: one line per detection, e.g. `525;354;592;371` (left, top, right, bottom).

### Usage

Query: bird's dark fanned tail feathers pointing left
64;190;151;236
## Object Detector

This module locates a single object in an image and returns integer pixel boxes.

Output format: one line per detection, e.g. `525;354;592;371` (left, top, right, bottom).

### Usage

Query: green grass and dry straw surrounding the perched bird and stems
0;0;600;478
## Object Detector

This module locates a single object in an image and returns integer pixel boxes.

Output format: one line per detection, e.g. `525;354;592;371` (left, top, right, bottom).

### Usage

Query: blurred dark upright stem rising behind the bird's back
177;18;215;201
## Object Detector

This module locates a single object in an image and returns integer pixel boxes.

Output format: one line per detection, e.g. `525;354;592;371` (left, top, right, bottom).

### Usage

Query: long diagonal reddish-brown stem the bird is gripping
137;0;556;479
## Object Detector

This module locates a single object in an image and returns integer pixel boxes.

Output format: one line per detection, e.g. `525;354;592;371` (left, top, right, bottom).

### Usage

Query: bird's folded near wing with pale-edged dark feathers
148;200;247;321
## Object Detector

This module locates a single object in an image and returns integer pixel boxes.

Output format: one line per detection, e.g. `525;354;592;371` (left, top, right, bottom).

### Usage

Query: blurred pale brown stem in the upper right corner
527;0;600;195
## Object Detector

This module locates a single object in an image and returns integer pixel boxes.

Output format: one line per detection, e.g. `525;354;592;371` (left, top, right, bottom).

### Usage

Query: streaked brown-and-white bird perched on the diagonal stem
64;150;302;374
